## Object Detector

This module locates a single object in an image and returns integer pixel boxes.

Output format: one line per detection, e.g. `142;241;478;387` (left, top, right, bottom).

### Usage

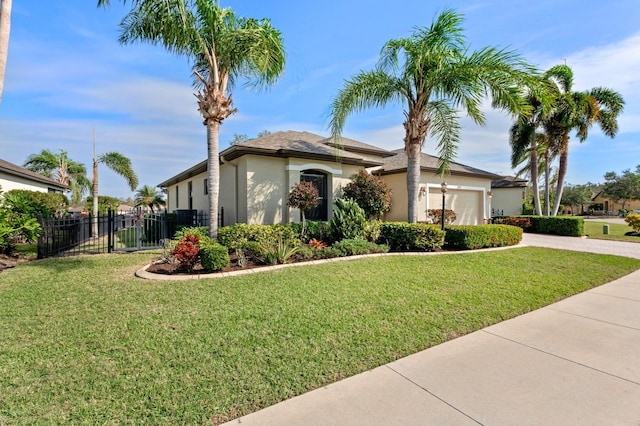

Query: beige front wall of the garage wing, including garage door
382;172;491;225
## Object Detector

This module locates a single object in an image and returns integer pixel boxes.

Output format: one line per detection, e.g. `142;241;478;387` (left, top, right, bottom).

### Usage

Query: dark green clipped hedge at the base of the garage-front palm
378;222;445;251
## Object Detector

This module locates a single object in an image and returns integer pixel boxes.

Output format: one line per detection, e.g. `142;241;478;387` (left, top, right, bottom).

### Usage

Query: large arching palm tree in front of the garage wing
330;10;537;222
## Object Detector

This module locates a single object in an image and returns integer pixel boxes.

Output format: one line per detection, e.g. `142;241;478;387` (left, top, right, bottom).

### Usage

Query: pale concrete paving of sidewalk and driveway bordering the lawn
222;234;640;426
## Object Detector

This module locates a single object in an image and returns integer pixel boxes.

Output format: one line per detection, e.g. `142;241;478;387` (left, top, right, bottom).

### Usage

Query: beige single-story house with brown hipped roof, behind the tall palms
158;131;521;225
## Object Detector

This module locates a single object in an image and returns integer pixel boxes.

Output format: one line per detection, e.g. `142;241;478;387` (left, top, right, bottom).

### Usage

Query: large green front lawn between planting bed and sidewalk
0;247;640;424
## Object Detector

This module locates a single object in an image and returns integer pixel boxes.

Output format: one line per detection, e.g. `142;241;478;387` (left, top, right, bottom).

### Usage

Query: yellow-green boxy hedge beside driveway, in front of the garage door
445;225;522;250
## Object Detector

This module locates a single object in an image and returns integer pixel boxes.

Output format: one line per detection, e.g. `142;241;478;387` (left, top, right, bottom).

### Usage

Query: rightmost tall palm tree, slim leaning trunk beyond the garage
542;65;624;216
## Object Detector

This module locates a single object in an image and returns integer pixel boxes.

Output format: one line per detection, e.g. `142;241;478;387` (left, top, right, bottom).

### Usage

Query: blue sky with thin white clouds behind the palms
0;0;640;198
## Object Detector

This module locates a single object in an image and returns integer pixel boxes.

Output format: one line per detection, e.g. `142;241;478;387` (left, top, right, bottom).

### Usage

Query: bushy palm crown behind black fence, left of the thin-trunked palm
24;149;91;205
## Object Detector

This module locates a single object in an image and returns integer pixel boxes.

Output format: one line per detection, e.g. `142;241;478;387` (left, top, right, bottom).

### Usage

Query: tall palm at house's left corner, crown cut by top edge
115;0;285;237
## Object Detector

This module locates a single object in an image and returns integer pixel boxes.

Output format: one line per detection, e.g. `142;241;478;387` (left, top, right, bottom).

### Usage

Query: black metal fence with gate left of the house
38;209;224;259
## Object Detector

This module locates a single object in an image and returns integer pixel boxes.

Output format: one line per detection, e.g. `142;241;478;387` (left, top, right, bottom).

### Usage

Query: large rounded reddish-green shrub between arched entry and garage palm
342;170;391;219
